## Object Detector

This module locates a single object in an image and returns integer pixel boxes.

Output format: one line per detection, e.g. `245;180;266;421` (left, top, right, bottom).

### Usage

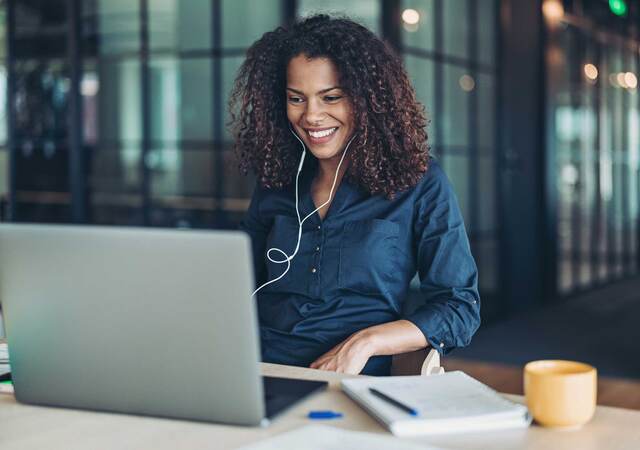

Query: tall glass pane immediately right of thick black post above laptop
80;0;146;225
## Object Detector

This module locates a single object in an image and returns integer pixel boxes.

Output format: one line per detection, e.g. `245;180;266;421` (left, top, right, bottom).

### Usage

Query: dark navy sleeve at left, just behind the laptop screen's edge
239;185;271;287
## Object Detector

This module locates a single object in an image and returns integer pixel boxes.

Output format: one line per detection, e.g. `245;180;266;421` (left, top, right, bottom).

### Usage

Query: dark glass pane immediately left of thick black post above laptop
7;0;70;222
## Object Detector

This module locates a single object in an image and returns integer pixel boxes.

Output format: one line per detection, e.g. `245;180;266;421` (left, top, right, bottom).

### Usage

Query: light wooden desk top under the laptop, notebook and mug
0;364;640;450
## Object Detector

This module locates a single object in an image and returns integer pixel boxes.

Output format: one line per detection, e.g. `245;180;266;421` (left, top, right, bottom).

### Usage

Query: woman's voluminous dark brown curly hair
228;14;429;198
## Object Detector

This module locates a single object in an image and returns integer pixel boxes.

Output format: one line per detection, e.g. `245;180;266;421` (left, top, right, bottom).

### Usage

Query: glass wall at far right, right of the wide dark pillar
546;16;640;294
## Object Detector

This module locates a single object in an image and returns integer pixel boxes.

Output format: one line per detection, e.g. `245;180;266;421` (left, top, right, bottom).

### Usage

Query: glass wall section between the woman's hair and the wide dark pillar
400;0;500;315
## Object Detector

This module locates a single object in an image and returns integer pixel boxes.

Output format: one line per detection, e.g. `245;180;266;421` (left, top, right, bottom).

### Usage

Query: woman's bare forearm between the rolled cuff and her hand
356;320;429;356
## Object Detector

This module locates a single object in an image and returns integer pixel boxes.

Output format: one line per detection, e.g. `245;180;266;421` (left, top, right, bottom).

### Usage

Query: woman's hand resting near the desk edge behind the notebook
309;331;373;375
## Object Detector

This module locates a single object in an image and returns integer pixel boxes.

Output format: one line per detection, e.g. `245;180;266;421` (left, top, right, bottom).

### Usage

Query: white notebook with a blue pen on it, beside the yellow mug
342;371;531;436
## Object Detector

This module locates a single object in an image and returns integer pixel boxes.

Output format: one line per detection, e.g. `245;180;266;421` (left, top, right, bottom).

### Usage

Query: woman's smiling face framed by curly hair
286;55;354;160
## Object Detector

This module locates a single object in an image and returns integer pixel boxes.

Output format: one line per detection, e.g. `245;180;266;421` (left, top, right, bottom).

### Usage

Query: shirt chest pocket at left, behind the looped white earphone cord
264;215;310;293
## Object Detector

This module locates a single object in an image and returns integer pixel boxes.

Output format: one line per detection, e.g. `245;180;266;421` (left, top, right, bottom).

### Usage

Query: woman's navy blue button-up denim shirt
241;155;480;375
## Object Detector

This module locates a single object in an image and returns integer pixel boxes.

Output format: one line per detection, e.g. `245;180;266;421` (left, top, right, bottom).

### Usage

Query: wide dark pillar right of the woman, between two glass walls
498;0;556;313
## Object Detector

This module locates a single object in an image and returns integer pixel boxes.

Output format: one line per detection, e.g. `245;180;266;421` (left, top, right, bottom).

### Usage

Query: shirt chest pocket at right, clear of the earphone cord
338;219;400;295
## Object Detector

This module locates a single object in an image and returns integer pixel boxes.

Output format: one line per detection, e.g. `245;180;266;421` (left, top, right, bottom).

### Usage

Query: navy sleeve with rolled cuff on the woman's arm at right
407;165;480;354
